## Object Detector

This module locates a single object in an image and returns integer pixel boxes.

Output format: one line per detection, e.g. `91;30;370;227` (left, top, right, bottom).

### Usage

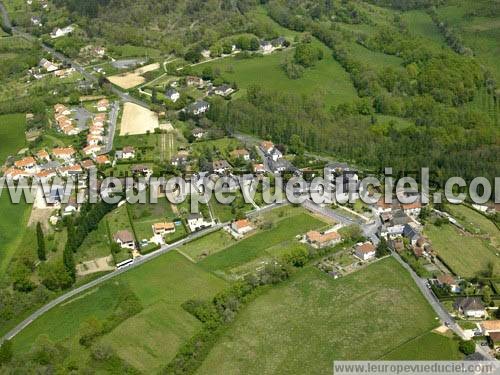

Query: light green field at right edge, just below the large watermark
425;224;500;277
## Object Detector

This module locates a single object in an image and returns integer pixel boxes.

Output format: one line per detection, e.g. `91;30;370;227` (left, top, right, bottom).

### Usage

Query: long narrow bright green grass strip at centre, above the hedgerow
200;213;325;272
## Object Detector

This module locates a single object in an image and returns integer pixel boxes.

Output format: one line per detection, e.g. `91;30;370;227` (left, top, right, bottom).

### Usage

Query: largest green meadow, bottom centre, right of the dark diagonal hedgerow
197;258;436;374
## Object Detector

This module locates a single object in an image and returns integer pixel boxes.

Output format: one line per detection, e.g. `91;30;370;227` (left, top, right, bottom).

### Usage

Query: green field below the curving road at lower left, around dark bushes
14;251;226;373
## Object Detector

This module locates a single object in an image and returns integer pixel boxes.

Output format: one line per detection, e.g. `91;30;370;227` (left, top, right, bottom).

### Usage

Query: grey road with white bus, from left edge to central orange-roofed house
1;223;228;342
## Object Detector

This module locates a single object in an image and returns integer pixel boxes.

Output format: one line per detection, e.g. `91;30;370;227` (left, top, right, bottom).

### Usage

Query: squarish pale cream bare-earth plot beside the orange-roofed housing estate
120;103;158;136
